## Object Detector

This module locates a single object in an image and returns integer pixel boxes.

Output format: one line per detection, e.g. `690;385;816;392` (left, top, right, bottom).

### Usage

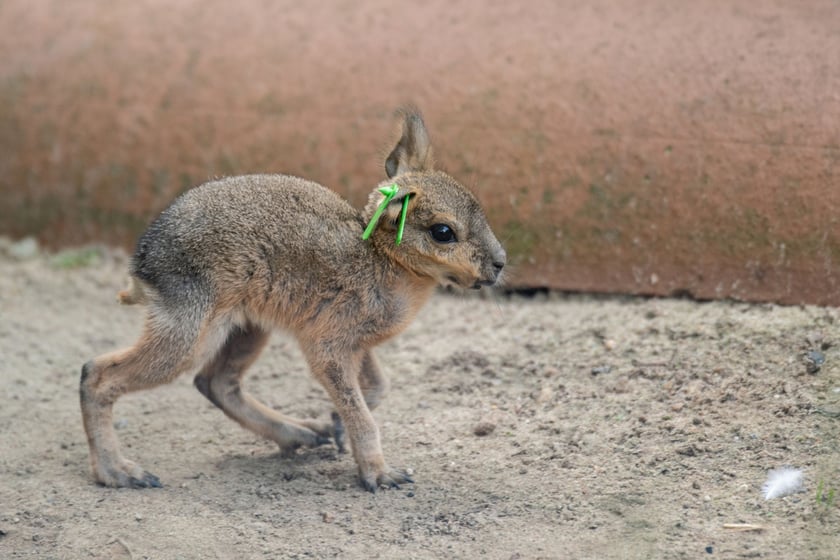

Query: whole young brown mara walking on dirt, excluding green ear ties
80;109;505;491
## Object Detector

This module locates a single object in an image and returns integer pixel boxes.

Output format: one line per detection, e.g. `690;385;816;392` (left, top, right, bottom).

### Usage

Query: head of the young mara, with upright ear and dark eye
364;108;506;288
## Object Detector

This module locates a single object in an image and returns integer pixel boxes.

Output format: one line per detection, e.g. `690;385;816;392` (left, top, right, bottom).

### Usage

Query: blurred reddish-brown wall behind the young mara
0;0;840;305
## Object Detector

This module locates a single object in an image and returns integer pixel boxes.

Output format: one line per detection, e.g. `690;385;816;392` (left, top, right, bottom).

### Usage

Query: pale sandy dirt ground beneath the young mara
0;241;840;559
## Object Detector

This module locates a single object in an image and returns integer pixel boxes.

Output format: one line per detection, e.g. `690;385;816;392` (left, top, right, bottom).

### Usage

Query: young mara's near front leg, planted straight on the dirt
306;348;414;492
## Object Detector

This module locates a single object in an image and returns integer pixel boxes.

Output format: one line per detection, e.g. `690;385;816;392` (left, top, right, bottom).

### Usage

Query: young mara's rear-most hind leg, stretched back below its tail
79;316;210;488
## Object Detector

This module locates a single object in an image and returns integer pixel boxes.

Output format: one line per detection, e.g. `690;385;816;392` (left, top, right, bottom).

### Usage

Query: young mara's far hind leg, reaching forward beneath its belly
195;325;332;451
